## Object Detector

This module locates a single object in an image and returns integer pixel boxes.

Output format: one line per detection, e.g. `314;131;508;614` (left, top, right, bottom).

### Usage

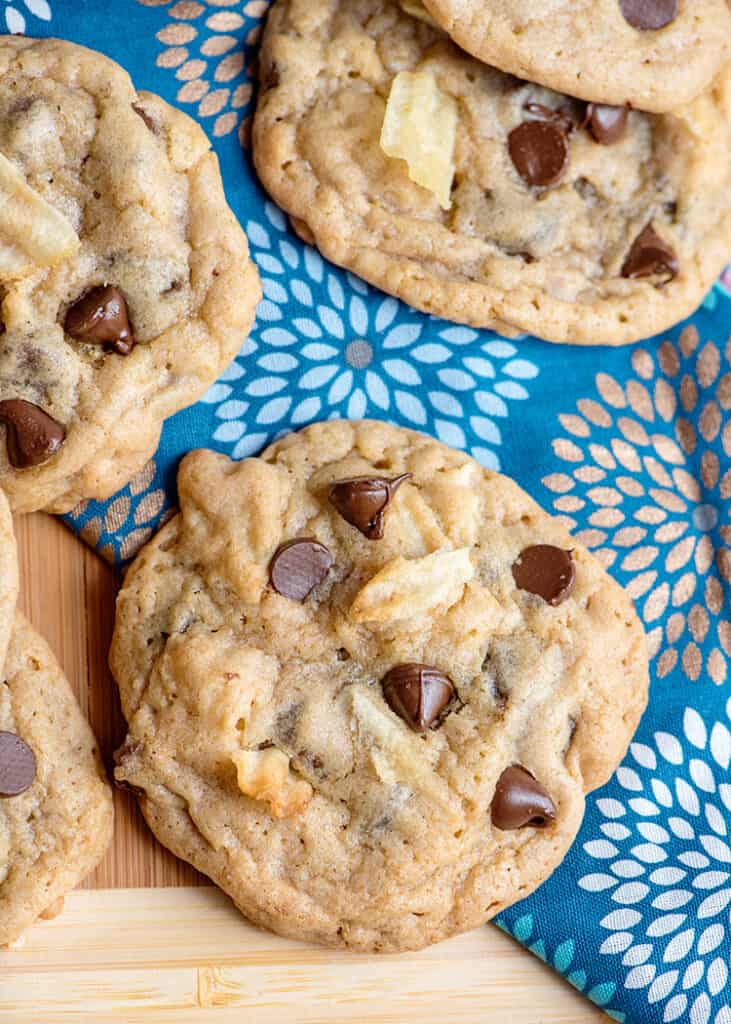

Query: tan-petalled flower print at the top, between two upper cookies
138;0;268;145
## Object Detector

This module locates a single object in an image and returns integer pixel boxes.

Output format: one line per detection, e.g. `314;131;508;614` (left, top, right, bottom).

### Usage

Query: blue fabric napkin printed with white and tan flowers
18;0;731;1024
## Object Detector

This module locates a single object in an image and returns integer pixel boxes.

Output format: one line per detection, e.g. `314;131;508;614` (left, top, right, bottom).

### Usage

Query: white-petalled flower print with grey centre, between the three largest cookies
196;202;539;469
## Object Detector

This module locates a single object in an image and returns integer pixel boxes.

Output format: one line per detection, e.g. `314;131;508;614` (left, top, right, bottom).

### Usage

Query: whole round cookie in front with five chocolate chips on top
111;421;648;950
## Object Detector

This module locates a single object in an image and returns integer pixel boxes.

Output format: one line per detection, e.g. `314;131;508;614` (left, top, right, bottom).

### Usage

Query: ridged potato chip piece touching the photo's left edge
0;154;80;278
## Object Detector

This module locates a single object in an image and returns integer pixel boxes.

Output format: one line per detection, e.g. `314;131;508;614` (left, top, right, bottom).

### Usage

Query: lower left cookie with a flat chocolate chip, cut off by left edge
0;613;113;946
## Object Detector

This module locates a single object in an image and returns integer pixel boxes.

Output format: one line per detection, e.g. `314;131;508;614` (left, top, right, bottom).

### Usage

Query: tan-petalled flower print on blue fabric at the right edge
543;327;731;685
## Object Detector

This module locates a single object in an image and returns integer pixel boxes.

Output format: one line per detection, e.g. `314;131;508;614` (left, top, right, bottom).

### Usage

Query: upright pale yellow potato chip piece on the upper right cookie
381;71;458;210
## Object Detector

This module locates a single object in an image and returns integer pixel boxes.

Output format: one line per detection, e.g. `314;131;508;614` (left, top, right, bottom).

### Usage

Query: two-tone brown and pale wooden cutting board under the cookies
0;514;608;1024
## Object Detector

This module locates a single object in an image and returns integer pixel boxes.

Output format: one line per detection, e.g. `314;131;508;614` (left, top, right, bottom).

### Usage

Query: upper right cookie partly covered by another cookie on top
253;0;731;344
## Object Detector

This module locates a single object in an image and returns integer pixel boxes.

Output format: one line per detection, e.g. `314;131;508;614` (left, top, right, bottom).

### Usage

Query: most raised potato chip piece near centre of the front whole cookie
349;548;475;623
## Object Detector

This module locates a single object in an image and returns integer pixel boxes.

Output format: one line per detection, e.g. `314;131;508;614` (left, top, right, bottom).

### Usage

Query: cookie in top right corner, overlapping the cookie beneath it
415;0;731;113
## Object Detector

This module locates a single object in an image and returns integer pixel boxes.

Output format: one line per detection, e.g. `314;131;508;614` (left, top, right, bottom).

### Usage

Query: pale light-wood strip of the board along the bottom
0;887;608;1024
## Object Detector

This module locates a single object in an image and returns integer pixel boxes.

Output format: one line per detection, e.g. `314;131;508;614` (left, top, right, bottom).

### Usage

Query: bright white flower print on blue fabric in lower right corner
578;699;731;1021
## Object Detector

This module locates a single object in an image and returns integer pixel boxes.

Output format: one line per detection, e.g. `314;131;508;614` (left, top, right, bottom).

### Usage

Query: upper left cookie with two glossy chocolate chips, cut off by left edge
0;36;260;512
